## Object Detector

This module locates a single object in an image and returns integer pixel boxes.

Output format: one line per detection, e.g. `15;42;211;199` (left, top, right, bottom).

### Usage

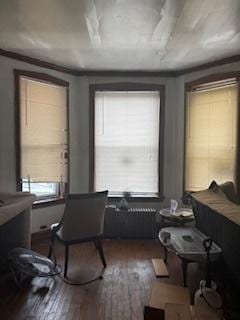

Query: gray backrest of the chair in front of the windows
58;191;108;241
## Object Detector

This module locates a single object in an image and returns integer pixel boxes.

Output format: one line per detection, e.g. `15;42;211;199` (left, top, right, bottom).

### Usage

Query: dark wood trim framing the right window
182;71;240;203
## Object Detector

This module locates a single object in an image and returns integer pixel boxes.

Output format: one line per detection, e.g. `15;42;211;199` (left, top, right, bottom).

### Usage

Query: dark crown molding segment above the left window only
0;48;78;76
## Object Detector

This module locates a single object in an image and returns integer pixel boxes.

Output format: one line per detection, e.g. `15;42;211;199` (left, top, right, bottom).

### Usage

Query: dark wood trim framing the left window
14;69;70;208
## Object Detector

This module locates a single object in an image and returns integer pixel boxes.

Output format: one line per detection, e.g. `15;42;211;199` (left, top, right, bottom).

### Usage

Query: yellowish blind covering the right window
185;81;238;191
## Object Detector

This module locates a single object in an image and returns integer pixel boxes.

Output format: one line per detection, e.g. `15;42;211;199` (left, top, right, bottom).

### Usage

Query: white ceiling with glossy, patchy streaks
0;0;240;71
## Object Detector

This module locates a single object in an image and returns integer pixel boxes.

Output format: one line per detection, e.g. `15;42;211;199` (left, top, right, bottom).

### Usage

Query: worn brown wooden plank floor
0;240;202;320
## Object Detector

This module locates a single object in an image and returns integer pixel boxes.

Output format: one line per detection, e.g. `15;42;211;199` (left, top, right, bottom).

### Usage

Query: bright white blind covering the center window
94;91;160;194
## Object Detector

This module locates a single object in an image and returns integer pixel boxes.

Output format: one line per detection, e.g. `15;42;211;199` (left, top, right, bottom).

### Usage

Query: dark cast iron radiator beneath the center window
104;208;157;239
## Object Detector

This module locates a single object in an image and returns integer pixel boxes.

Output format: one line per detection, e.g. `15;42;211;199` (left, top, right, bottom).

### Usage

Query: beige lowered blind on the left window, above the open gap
20;77;67;182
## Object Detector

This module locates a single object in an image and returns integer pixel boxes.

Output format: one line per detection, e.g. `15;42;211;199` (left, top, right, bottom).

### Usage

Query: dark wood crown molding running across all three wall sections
0;48;240;78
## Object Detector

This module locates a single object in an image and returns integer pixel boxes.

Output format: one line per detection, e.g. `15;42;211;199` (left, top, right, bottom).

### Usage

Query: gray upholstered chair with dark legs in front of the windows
48;191;108;277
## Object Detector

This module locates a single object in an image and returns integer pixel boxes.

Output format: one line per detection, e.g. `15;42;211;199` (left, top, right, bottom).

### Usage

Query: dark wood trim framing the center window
89;82;165;201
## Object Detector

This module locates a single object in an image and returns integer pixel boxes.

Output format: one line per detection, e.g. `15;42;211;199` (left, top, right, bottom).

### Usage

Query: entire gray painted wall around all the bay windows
0;53;240;232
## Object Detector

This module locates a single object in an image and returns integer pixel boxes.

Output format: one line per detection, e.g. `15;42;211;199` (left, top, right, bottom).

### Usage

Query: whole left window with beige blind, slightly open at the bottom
16;71;68;201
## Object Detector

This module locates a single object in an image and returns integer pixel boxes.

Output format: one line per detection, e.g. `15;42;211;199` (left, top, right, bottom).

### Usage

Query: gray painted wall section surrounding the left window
0;57;81;232
